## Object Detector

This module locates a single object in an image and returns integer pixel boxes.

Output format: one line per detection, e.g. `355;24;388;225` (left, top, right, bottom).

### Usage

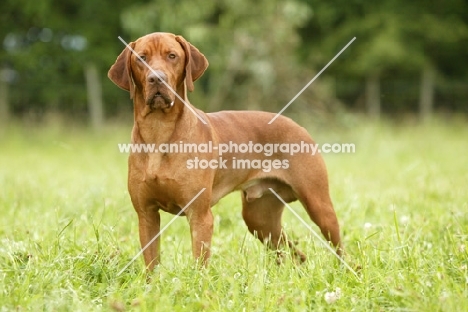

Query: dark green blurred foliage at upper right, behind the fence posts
300;0;468;113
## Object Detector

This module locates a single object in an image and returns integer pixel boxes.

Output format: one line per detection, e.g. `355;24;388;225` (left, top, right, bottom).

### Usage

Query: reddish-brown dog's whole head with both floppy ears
108;33;208;108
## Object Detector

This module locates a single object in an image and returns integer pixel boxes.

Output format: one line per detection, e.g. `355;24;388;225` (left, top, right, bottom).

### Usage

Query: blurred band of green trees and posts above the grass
0;0;468;128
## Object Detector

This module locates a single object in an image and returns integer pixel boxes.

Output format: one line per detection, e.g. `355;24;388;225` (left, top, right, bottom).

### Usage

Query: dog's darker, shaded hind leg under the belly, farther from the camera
242;192;306;262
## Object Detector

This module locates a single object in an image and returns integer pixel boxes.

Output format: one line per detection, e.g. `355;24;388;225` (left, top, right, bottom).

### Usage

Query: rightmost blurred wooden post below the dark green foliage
419;65;436;122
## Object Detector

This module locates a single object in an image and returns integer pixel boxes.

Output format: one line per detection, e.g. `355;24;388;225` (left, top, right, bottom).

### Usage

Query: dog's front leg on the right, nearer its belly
187;205;213;266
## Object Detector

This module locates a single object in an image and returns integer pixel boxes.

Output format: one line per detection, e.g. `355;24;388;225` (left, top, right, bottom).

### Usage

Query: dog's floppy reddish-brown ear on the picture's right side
176;36;208;92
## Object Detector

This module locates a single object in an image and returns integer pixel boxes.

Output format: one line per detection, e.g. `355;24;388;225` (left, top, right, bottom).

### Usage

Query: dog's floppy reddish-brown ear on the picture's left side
107;42;135;99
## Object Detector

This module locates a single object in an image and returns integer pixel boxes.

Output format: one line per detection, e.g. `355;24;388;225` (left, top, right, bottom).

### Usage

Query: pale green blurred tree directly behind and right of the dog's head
123;0;322;116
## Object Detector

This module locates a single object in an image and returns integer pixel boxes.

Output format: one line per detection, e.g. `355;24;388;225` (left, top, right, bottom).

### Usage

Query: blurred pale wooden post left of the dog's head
85;63;104;130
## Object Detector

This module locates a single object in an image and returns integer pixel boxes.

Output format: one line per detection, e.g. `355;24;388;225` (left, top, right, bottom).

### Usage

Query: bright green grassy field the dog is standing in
0;121;468;311
